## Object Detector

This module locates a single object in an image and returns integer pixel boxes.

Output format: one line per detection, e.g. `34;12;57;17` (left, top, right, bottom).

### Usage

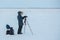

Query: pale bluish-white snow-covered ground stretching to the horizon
0;9;60;40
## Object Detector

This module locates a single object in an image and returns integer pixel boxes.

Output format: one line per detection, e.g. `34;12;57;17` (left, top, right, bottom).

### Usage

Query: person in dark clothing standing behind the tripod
17;11;27;34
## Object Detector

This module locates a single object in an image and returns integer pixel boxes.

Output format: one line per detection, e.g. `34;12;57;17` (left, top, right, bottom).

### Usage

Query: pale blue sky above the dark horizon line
0;0;60;8
